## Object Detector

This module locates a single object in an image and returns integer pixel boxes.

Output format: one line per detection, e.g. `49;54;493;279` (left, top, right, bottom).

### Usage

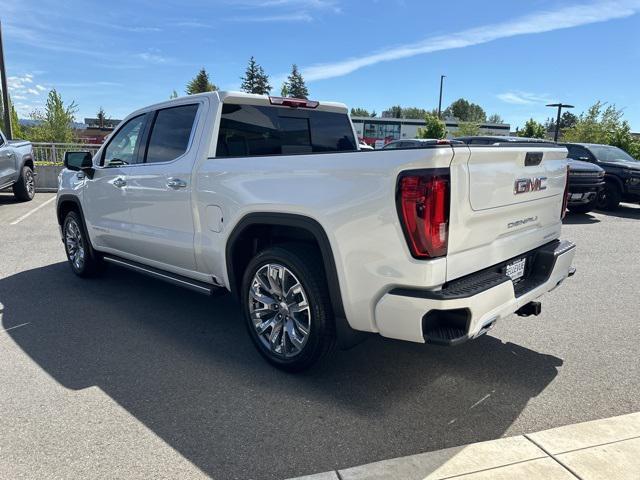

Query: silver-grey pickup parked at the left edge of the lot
0;131;36;201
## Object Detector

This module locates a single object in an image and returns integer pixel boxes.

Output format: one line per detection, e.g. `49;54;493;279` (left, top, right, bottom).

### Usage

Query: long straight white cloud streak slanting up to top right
300;0;640;81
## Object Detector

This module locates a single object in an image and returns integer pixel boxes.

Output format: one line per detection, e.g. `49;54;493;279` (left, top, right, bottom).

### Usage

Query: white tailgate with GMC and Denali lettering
447;145;567;280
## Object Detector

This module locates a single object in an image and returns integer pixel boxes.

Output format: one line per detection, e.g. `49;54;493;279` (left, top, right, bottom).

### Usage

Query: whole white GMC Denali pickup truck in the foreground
57;92;575;371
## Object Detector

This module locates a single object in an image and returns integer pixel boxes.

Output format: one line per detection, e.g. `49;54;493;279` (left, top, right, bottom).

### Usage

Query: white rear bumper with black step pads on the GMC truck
375;240;575;345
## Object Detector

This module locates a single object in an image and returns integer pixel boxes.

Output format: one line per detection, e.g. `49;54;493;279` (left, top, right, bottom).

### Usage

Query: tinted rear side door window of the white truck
146;105;198;163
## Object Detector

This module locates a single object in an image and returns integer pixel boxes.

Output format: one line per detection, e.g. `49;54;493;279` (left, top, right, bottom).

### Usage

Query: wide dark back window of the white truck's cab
216;104;357;157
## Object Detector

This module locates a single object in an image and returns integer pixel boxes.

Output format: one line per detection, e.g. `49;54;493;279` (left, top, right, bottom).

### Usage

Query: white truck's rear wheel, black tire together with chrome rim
241;245;336;372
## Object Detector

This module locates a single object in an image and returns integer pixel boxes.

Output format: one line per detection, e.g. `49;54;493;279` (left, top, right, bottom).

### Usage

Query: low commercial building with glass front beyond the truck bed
351;117;511;146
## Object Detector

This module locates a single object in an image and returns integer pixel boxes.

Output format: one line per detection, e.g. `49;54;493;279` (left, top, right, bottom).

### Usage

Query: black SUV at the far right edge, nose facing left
562;143;640;210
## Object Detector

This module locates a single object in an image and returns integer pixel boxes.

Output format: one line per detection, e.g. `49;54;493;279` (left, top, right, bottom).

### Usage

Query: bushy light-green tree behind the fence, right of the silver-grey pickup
30;88;78;143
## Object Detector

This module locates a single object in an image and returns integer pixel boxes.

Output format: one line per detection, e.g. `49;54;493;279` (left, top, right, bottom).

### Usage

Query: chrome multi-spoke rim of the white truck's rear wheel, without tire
249;263;311;358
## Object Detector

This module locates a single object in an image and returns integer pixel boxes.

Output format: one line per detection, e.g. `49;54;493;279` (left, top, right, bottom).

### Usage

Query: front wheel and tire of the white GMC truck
62;211;106;278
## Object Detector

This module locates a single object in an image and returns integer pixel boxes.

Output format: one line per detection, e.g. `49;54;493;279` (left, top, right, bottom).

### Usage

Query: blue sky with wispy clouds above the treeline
0;0;640;131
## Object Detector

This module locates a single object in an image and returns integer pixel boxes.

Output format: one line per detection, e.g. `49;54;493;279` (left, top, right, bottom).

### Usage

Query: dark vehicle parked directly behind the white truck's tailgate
455;135;604;213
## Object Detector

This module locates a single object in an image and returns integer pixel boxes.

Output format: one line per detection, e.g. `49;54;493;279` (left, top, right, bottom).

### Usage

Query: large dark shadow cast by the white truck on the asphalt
0;263;562;478
